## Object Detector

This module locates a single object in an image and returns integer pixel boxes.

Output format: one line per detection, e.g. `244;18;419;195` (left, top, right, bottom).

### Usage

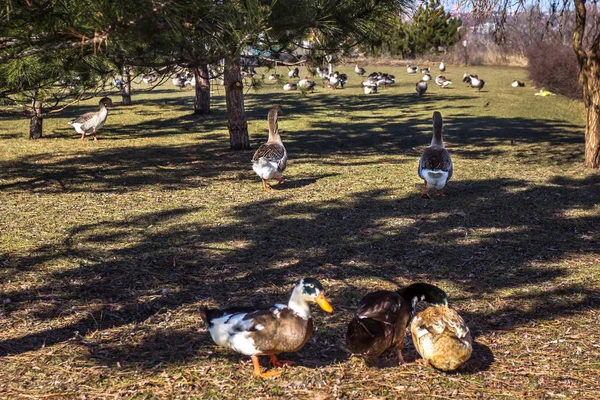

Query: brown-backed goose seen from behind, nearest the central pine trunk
252;104;287;191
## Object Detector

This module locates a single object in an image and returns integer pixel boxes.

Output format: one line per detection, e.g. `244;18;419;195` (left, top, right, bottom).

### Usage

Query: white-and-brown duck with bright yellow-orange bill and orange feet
200;278;333;378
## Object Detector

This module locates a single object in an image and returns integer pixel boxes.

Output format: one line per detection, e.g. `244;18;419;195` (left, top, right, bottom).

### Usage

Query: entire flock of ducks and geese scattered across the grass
63;61;536;378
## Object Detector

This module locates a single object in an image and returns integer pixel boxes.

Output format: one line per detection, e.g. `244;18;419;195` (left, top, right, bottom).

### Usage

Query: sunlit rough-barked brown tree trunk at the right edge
573;0;600;168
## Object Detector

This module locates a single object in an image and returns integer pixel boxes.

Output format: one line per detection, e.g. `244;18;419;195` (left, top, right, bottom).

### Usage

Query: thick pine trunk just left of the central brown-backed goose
224;58;250;150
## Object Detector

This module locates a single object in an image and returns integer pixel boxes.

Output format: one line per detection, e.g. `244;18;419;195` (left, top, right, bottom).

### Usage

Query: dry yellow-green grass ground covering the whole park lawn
0;65;600;399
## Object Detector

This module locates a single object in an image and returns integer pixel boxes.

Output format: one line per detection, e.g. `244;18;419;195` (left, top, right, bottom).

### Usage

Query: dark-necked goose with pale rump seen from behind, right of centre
419;111;452;198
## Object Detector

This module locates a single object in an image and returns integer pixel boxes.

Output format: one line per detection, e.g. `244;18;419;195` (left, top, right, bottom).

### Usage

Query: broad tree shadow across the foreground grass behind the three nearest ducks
0;172;600;371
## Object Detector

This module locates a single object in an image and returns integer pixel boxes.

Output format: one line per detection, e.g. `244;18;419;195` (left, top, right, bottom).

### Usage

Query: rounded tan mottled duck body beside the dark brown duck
410;304;473;371
